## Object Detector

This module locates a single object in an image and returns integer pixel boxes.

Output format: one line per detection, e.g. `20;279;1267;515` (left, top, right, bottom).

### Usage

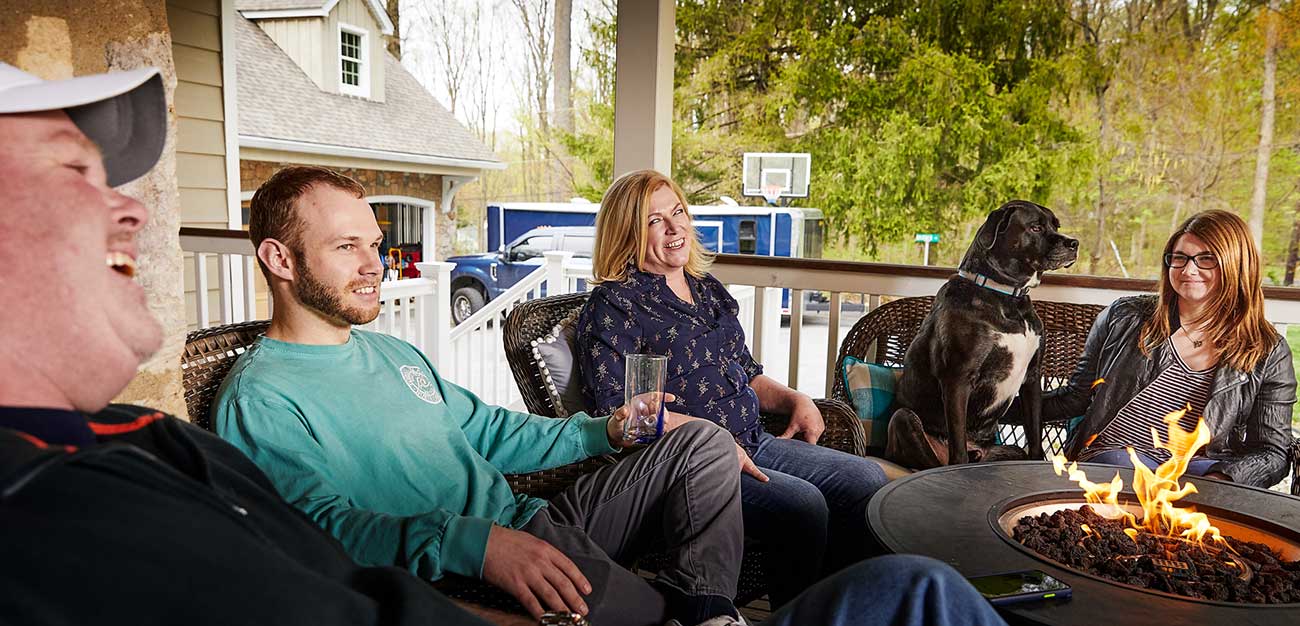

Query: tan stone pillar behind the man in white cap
0;0;186;417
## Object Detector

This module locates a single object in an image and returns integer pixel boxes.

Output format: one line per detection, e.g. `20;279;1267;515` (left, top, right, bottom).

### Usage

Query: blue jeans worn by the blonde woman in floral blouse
740;432;887;608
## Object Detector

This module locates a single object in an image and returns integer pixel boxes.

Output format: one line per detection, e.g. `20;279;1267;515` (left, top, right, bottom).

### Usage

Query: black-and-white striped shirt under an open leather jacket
1079;340;1214;462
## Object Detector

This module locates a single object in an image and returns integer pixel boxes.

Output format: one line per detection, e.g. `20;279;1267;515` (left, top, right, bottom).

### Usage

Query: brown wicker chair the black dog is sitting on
831;296;1104;452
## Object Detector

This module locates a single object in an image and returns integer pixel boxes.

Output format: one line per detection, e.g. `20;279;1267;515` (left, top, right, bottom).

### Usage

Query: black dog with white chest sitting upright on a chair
885;200;1079;469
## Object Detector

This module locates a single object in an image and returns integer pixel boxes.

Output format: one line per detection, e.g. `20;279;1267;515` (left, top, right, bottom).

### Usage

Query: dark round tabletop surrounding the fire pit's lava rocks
866;461;1300;626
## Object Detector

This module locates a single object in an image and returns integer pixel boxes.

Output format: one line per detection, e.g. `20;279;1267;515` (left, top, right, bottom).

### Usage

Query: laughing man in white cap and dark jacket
0;64;496;625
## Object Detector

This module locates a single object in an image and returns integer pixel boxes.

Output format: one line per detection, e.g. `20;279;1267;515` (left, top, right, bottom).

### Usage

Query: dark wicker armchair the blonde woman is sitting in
503;294;866;605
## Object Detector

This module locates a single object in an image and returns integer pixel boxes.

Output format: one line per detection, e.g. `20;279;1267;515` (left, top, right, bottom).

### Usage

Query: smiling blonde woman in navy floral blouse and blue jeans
577;170;885;605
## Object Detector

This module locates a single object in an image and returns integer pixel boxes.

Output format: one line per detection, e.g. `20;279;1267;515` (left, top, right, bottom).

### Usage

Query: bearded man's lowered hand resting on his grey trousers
484;525;592;618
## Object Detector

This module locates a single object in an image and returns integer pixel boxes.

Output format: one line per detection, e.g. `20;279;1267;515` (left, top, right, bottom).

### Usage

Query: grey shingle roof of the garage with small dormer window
235;15;501;168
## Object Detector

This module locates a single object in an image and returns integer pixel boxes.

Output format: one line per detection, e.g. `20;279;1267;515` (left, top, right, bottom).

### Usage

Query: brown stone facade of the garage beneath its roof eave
239;160;456;261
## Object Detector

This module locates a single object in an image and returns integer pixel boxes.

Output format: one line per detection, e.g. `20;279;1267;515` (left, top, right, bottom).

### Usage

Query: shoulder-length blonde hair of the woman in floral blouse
592;170;714;283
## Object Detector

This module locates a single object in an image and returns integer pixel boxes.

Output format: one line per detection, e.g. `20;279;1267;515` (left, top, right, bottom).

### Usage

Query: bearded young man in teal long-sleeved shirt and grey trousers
212;168;742;626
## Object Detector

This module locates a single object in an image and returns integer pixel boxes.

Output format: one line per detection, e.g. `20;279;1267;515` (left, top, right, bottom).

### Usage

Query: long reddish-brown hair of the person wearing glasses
1141;210;1278;371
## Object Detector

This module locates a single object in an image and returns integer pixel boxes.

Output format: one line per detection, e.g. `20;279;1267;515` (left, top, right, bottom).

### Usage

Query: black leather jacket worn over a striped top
1043;296;1296;487
